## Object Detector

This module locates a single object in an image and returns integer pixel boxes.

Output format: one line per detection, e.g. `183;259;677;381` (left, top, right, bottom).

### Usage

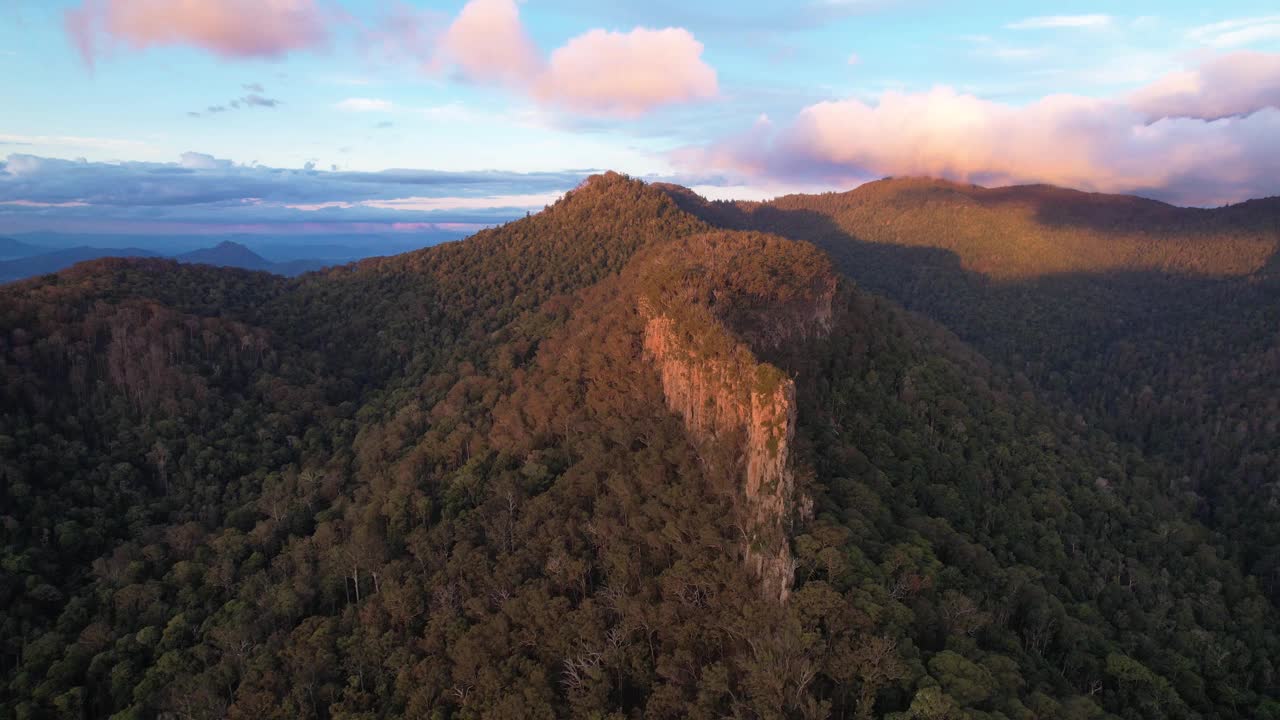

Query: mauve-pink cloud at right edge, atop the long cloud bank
1129;53;1280;120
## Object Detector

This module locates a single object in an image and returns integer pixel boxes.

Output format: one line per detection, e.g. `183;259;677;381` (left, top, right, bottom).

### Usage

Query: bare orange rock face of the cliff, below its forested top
640;230;836;601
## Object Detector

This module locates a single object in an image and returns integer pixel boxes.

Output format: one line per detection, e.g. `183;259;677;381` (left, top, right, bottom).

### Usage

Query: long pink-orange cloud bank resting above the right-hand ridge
675;54;1280;205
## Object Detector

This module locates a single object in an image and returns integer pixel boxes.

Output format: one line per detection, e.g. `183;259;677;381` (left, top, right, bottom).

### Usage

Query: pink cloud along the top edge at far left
65;0;328;64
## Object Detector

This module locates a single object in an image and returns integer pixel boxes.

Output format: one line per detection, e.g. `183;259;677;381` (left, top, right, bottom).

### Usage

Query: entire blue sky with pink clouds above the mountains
0;0;1280;232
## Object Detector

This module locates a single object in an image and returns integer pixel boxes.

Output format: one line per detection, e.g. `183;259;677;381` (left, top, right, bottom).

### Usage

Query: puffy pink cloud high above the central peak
535;28;718;117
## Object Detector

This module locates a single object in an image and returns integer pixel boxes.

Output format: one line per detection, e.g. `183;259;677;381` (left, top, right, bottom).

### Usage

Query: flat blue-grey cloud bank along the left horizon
0;152;586;232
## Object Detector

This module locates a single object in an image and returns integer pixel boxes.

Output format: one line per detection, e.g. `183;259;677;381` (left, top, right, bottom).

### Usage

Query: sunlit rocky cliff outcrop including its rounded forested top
640;233;836;601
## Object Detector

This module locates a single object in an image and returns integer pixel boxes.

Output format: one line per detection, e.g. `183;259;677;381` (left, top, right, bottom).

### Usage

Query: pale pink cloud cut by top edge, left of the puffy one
438;0;543;86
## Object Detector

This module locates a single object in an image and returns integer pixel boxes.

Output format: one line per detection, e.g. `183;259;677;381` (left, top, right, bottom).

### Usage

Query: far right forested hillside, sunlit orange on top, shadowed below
669;179;1280;598
